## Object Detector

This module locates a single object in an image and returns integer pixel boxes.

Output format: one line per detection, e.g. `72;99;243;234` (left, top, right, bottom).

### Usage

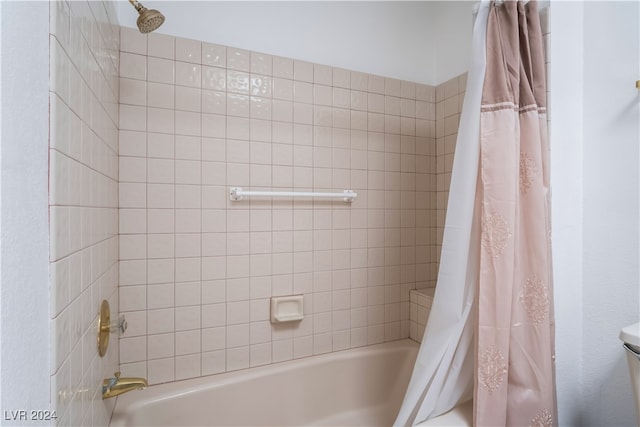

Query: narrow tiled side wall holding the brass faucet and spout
49;1;120;426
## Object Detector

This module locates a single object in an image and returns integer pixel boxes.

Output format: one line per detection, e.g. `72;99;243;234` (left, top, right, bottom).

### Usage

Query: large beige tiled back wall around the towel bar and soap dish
119;28;437;383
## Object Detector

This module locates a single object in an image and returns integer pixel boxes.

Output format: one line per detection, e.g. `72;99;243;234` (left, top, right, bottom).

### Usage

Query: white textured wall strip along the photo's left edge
0;2;51;425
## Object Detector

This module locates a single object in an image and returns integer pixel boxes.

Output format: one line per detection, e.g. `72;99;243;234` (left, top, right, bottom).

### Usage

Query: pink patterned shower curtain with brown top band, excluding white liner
474;1;557;426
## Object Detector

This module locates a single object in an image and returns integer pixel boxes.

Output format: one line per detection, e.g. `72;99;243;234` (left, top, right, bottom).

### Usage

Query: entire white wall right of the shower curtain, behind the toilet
551;2;640;426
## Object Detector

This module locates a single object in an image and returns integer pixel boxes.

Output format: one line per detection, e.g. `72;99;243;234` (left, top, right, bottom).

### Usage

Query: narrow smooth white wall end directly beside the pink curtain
549;2;583;426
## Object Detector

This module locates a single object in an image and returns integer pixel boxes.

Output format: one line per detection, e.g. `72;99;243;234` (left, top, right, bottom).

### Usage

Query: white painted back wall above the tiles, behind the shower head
118;1;440;85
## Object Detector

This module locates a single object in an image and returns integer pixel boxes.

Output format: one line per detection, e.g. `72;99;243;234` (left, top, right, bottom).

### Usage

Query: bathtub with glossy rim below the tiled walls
110;340;419;426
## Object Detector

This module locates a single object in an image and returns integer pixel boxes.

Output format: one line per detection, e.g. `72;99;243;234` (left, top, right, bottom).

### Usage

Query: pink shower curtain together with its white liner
395;0;557;426
